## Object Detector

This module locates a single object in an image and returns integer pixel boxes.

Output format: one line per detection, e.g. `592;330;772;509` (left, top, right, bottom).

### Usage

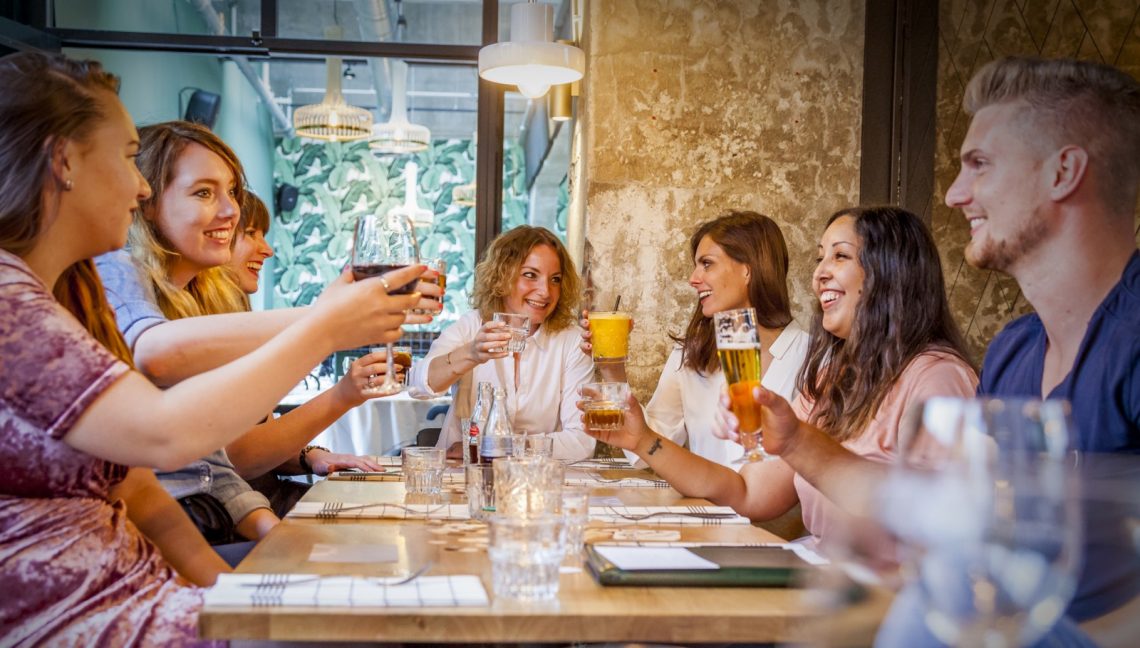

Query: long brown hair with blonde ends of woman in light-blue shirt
129;121;245;319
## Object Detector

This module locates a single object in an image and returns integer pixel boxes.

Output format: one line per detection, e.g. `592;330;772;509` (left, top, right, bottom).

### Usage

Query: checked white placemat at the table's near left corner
205;574;490;608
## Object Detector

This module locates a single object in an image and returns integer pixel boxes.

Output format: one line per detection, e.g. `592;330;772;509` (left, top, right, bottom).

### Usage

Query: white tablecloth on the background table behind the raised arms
282;391;451;455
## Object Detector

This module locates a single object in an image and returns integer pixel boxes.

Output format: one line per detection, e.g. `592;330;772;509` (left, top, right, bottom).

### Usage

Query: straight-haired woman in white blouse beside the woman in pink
583;211;808;469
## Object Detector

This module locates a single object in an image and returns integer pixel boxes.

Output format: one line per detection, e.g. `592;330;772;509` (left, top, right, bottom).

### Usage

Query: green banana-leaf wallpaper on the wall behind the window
269;137;551;330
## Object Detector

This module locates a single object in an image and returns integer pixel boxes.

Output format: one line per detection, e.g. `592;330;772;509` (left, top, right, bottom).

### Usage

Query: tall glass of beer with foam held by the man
713;308;771;463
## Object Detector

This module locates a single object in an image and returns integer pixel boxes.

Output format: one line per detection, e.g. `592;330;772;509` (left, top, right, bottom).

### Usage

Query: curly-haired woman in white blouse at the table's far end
408;226;592;460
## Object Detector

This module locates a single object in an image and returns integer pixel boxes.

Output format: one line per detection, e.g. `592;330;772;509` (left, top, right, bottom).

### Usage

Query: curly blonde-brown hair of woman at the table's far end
471;225;581;331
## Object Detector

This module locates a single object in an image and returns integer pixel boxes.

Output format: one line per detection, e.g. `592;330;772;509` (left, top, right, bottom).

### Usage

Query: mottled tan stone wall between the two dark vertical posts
576;0;864;398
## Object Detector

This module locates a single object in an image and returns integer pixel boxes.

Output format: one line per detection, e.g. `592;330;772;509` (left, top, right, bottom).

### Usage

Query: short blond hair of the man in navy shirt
962;57;1140;213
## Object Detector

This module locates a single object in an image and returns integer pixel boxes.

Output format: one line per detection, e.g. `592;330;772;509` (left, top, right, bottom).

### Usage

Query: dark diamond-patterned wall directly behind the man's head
929;0;1140;361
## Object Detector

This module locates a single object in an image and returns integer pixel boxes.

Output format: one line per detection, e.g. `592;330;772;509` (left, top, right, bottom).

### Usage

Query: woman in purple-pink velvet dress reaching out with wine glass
0;52;424;646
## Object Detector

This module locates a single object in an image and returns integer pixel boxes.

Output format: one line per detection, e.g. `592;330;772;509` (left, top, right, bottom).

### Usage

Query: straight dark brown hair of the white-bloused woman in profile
670;210;792;374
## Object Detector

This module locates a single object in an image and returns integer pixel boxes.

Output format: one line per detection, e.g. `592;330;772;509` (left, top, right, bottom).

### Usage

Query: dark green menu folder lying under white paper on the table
585;544;813;588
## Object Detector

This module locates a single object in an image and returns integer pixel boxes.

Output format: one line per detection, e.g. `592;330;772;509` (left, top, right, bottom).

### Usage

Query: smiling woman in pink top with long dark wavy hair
591;206;977;538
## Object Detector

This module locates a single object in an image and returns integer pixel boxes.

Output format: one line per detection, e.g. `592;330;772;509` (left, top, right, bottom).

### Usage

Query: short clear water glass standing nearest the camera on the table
487;513;567;601
